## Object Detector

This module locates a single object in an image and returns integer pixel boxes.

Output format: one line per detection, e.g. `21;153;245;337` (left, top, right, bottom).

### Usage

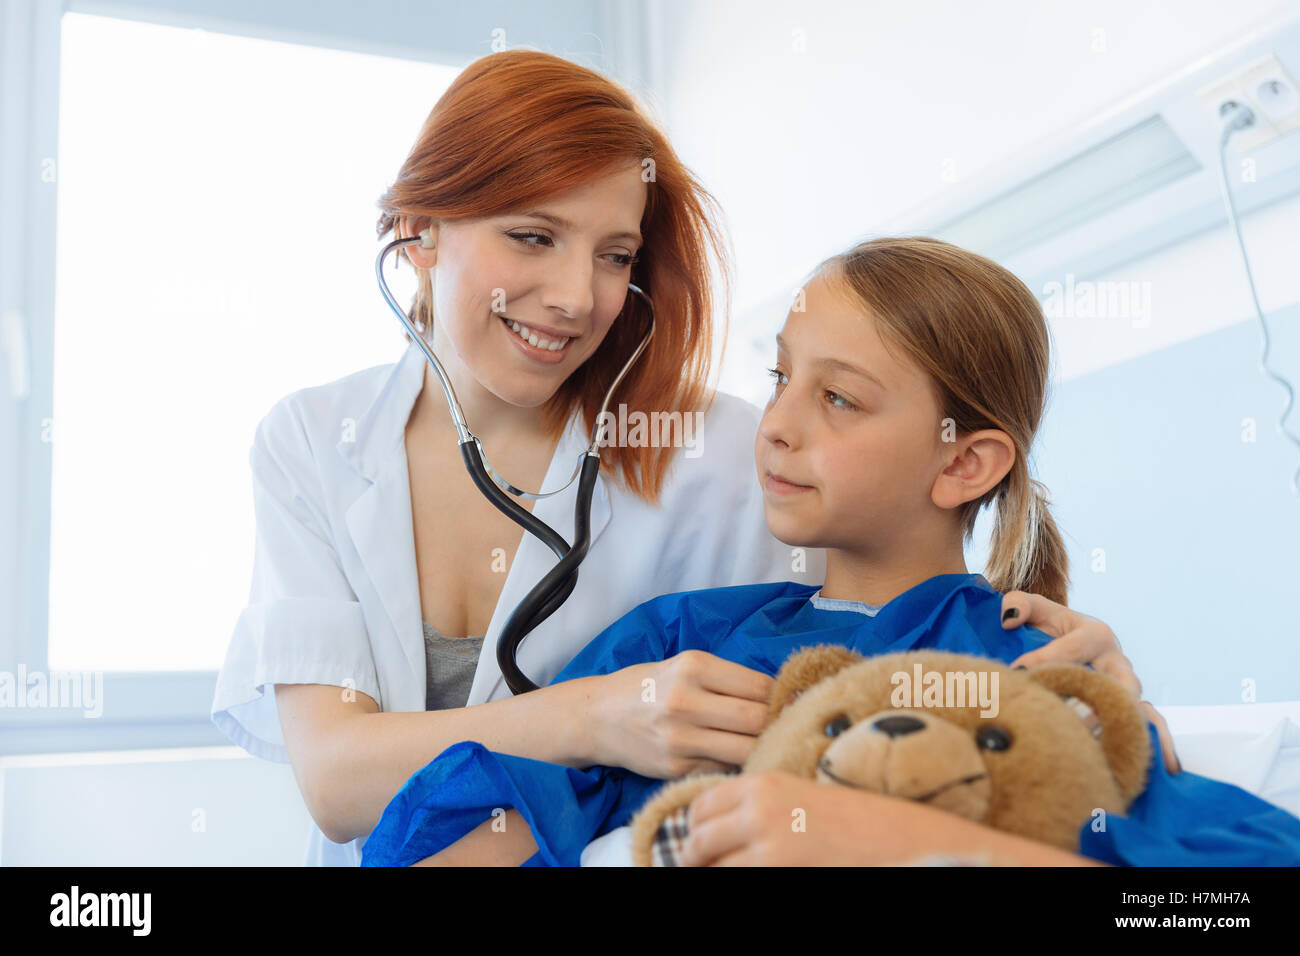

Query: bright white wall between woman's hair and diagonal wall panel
639;0;1295;389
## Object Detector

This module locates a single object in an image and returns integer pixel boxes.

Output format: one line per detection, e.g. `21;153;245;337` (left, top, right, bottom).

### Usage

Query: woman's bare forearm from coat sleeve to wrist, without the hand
276;679;597;842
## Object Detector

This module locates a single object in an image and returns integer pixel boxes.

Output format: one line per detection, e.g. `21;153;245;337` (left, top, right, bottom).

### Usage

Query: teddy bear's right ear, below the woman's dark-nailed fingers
1026;663;1151;803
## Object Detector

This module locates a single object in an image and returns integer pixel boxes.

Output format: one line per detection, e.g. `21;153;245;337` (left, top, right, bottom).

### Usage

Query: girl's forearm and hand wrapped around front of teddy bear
681;771;1095;866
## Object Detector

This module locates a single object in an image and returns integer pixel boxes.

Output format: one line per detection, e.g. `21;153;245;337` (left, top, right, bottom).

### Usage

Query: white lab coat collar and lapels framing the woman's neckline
335;342;612;710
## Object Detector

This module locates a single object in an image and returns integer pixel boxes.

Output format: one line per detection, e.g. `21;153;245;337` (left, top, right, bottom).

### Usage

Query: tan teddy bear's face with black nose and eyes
745;652;1145;848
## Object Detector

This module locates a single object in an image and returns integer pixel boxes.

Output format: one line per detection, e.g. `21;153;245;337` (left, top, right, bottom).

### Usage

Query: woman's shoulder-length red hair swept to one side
377;49;731;503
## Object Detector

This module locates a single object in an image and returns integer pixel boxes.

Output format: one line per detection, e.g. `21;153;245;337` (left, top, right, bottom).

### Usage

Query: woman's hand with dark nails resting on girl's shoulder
1002;591;1183;774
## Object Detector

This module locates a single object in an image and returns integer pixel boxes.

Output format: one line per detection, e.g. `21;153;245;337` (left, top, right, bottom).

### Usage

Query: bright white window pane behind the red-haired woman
48;13;458;671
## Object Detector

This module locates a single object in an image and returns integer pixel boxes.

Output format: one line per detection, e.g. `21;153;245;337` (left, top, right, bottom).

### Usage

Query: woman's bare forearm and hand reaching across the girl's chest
276;650;774;860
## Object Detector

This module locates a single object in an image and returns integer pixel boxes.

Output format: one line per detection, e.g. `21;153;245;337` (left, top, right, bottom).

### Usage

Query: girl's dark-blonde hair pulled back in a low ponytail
816;237;1070;605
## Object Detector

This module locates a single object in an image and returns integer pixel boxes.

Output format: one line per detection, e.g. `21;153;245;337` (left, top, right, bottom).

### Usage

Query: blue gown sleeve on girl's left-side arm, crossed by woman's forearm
361;587;772;866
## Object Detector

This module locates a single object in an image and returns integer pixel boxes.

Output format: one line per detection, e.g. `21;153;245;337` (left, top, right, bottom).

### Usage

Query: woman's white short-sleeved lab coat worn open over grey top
212;343;826;865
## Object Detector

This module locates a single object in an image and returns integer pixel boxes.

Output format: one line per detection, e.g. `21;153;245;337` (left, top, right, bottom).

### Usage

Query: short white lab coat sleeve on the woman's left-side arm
212;399;381;763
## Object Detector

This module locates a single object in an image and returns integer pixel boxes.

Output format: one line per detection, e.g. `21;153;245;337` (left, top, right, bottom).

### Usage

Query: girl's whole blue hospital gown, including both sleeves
361;574;1300;866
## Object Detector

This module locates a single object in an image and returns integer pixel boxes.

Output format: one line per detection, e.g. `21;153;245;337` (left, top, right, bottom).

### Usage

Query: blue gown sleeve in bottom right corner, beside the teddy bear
1079;723;1300;866
